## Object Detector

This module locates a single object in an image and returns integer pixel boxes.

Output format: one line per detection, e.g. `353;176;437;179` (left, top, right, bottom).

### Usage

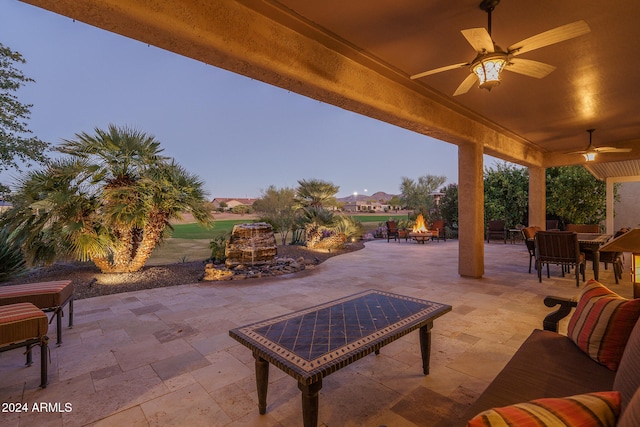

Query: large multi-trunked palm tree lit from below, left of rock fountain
3;125;213;273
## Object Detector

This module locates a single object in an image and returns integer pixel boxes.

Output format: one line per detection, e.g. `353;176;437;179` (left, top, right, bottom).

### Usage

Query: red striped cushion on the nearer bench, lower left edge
0;303;49;346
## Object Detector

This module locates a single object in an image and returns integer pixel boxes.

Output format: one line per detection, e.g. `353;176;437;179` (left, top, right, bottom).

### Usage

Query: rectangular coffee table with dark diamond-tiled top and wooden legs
229;289;451;427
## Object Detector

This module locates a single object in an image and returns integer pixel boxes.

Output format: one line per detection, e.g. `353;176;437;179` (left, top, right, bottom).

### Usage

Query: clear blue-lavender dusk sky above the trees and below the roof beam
0;0;498;198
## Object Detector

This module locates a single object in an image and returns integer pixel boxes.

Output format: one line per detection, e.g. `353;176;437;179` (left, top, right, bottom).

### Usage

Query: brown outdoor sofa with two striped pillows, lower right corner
464;280;640;427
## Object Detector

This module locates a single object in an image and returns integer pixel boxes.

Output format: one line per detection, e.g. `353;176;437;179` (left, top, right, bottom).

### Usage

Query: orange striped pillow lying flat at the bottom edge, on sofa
467;391;620;427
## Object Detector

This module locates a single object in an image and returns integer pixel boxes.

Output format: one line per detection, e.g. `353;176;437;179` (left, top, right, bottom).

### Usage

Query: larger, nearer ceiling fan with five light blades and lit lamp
411;0;591;96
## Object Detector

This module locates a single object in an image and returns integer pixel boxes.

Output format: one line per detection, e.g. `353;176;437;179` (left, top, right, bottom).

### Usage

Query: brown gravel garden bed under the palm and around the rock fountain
0;242;364;299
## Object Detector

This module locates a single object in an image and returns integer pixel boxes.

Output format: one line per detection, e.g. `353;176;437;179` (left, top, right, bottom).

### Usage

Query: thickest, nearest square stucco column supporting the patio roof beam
458;144;484;278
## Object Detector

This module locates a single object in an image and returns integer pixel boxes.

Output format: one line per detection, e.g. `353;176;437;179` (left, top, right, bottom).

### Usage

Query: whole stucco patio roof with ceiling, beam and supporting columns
18;0;640;277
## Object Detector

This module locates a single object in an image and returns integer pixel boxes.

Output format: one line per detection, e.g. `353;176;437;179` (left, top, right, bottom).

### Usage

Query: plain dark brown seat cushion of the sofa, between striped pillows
465;329;615;419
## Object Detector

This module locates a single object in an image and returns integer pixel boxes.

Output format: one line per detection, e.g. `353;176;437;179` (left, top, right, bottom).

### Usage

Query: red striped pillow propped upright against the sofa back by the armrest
567;280;640;371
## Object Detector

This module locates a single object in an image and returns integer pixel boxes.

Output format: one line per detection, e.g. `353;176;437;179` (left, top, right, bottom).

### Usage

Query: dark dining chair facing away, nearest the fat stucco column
534;231;585;287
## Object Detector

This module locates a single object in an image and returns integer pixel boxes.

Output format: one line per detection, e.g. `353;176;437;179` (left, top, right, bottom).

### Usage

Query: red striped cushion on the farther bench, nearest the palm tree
0;280;73;309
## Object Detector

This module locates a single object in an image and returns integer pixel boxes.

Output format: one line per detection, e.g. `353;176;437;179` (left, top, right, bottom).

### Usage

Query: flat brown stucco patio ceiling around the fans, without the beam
266;0;640;166
